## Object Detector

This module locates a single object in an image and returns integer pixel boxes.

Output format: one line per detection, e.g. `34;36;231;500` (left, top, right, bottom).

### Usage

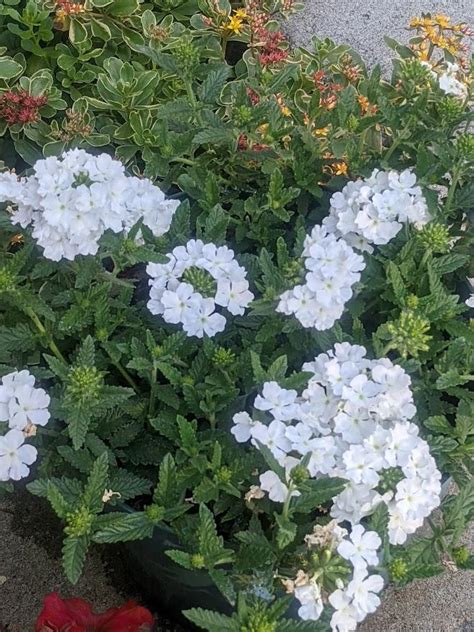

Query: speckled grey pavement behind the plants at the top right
285;0;474;70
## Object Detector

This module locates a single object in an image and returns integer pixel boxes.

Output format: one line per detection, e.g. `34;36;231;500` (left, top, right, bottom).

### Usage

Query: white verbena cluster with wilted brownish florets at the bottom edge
292;520;384;632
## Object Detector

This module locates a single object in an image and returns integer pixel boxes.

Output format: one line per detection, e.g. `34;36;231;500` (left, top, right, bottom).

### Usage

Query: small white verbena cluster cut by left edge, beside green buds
0;371;50;481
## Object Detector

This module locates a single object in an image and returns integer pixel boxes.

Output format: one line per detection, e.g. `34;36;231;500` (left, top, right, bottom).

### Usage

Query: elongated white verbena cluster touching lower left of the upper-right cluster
276;226;365;330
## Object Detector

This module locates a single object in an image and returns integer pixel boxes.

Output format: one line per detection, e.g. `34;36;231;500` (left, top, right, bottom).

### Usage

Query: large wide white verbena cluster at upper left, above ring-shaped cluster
0;149;179;261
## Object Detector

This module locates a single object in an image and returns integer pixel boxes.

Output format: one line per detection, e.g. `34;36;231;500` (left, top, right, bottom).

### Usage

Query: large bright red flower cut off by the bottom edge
35;593;153;632
